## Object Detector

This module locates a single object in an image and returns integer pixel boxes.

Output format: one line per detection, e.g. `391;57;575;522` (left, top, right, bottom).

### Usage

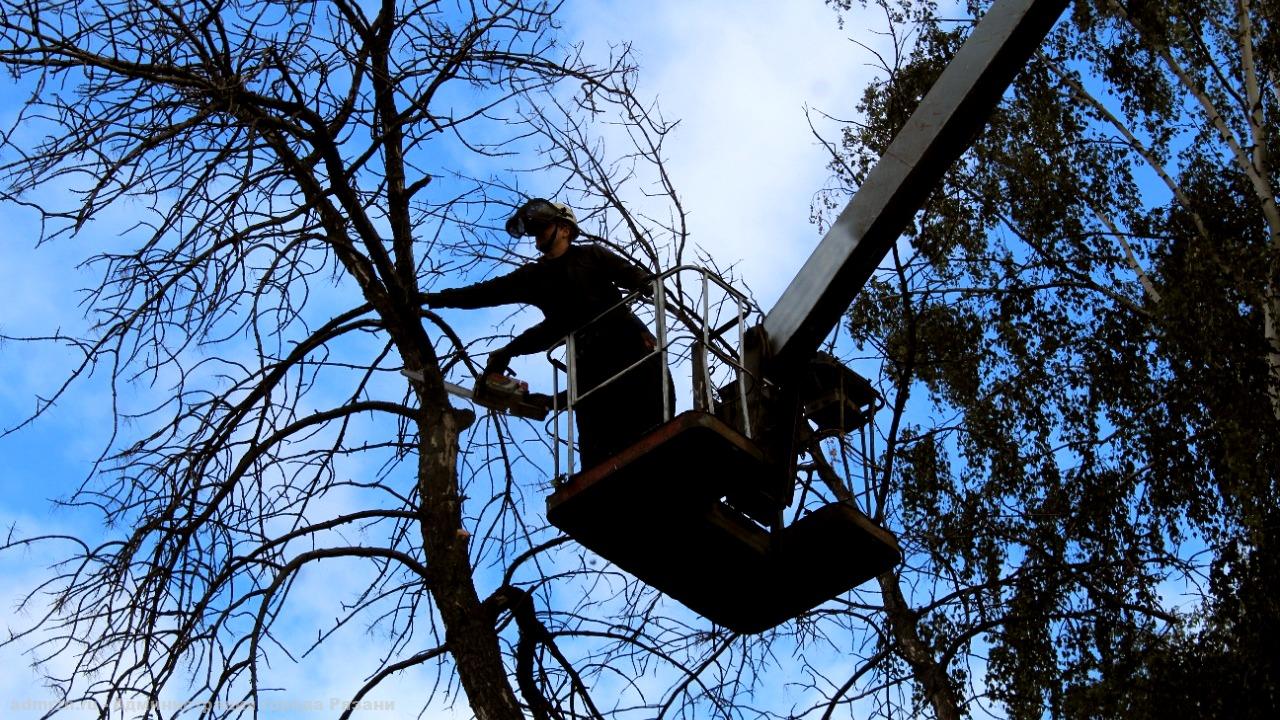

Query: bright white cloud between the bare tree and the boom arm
566;0;879;304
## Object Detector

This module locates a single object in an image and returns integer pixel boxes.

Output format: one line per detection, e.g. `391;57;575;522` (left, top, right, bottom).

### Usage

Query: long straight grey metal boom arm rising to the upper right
764;0;1069;371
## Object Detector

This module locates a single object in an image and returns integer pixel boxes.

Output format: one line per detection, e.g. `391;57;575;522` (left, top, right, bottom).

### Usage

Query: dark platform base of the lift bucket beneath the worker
547;410;901;633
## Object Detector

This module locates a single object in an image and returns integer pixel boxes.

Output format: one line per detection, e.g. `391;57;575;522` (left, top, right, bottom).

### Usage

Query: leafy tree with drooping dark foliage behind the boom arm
815;0;1280;717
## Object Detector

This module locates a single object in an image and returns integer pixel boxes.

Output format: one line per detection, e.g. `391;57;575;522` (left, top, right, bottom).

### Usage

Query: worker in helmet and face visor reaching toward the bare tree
424;199;673;468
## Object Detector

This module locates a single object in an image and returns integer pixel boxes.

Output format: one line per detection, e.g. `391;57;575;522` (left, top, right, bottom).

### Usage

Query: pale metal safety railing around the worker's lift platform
547;265;759;478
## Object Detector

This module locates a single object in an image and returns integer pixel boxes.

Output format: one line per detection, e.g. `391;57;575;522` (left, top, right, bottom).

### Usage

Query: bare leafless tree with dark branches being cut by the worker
0;0;721;717
